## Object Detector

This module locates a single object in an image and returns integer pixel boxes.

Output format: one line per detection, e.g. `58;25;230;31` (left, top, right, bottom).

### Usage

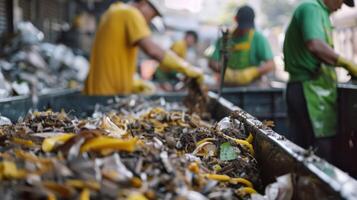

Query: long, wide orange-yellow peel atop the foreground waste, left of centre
80;136;138;153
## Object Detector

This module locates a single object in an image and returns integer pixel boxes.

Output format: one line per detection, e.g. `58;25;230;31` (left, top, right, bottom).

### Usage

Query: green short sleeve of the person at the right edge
295;3;325;42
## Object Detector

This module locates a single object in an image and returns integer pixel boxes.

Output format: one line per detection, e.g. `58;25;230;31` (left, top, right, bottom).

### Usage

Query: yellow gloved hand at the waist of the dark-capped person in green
224;67;260;85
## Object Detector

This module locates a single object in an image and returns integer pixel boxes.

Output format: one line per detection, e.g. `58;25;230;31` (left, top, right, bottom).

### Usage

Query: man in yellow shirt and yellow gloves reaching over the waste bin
84;0;203;96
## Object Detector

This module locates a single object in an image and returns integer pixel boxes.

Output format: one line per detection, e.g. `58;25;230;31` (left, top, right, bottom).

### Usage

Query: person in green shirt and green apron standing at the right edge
284;0;357;160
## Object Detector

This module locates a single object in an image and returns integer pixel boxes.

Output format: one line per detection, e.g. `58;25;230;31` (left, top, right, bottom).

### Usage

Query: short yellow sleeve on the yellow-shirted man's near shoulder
126;8;151;44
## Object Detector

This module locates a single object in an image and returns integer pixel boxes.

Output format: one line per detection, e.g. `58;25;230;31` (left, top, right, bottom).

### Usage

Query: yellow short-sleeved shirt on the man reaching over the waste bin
84;2;150;96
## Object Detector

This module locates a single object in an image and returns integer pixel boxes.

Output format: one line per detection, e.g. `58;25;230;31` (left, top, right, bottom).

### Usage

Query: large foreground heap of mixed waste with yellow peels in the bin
0;97;262;200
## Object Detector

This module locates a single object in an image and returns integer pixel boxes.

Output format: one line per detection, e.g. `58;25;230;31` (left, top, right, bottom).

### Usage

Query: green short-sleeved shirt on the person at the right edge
284;0;333;81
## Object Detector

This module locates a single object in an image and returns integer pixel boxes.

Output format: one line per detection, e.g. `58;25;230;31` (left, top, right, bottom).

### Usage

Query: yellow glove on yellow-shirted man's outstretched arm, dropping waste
160;51;203;84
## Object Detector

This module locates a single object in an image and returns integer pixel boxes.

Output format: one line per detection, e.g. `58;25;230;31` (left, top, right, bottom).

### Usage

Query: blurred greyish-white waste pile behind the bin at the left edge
0;22;89;98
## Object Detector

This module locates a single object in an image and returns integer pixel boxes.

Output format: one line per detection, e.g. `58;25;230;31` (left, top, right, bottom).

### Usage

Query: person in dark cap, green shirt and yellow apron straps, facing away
209;6;275;86
